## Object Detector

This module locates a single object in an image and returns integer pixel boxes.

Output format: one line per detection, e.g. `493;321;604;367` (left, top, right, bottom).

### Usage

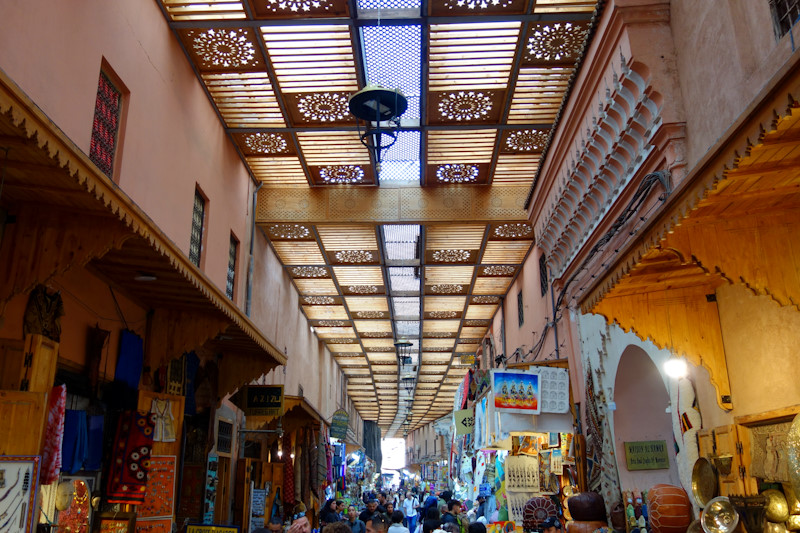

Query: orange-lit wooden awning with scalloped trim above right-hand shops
581;54;800;409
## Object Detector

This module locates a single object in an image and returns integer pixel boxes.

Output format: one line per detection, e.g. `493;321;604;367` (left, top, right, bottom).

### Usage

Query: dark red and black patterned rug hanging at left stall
106;411;155;505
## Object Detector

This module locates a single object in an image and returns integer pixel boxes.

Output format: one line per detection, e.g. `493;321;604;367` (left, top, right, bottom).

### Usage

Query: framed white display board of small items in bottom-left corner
0;455;41;533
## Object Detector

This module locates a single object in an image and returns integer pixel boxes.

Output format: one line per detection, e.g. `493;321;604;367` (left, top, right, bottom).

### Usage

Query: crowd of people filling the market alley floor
256;489;536;533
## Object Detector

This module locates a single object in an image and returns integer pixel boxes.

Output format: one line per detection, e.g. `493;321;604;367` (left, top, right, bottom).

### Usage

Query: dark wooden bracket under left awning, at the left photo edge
0;206;134;308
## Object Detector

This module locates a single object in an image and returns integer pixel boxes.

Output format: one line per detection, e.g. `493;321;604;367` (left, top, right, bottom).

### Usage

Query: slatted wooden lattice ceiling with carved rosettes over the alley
160;0;597;432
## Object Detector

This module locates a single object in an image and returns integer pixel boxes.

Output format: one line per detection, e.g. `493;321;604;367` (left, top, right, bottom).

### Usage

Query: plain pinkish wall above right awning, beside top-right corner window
670;0;800;168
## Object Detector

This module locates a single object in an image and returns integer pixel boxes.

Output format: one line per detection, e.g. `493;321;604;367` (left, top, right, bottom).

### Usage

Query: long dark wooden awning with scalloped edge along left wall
0;71;286;394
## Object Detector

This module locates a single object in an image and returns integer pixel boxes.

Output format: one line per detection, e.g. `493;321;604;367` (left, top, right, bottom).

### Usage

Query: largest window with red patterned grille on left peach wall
89;72;122;177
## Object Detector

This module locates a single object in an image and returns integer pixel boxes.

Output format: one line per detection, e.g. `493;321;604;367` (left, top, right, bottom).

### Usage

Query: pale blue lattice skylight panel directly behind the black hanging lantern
361;26;422;119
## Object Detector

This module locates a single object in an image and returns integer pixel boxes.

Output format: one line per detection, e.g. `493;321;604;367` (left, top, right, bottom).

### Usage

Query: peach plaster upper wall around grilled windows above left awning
0;0;251;305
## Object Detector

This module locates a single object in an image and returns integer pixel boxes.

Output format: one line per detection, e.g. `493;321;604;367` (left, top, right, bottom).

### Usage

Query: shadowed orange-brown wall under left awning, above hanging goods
0;267;147;374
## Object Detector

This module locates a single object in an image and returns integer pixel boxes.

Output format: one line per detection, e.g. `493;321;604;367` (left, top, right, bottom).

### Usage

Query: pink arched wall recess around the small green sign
614;346;680;490
